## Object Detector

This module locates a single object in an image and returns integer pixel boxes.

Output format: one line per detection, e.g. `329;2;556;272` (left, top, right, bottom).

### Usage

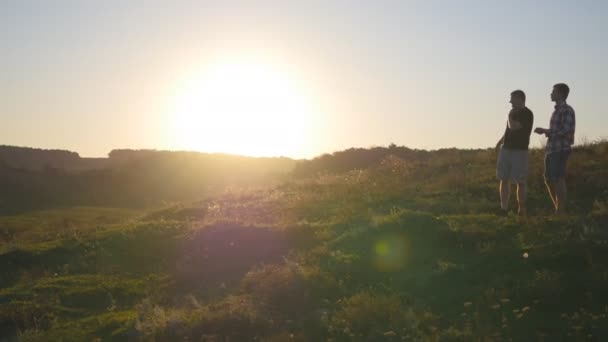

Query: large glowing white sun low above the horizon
169;60;319;157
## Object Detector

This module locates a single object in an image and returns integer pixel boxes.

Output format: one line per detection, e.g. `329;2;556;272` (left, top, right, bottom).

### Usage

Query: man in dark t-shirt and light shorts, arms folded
496;90;534;215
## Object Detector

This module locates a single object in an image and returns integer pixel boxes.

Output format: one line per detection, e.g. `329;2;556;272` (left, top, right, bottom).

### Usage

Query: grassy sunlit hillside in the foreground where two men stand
0;143;608;341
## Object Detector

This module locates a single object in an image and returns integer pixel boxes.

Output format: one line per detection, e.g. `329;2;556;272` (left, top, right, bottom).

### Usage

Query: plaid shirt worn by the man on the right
546;102;576;153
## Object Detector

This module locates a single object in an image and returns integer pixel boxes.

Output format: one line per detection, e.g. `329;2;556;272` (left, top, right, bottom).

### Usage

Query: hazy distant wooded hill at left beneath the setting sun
0;146;296;214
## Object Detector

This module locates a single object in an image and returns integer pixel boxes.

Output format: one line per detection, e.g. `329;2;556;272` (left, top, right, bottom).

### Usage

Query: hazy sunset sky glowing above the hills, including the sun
0;0;608;158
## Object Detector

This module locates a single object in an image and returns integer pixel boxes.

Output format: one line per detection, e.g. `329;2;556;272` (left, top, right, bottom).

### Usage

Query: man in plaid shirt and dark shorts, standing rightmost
534;83;576;215
